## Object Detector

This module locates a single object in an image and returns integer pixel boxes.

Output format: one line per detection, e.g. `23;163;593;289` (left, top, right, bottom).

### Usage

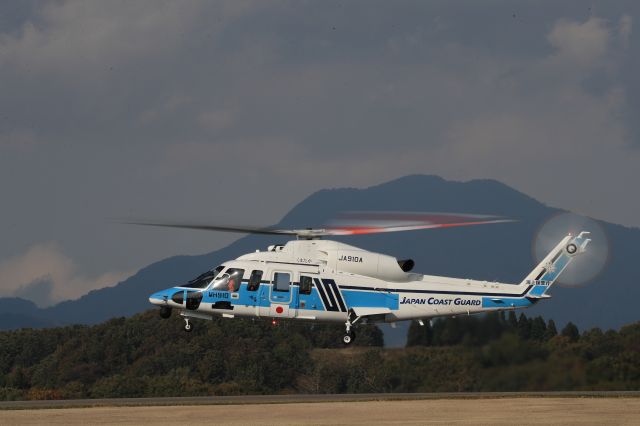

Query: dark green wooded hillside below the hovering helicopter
0;310;640;399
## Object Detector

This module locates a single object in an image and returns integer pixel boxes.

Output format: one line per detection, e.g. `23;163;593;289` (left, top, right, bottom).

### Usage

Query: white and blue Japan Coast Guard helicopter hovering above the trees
139;213;591;345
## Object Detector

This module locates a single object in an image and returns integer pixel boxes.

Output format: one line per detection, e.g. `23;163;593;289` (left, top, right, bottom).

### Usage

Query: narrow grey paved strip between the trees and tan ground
0;391;640;410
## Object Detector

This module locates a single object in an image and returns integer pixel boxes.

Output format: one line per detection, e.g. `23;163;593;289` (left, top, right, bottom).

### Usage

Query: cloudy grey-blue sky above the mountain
0;0;640;306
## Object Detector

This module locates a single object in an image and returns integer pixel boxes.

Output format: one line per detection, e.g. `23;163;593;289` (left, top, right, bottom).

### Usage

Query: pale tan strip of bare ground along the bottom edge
0;396;640;426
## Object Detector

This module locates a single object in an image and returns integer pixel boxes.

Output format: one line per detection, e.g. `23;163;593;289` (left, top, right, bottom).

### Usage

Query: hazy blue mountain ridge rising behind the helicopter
0;175;640;342
